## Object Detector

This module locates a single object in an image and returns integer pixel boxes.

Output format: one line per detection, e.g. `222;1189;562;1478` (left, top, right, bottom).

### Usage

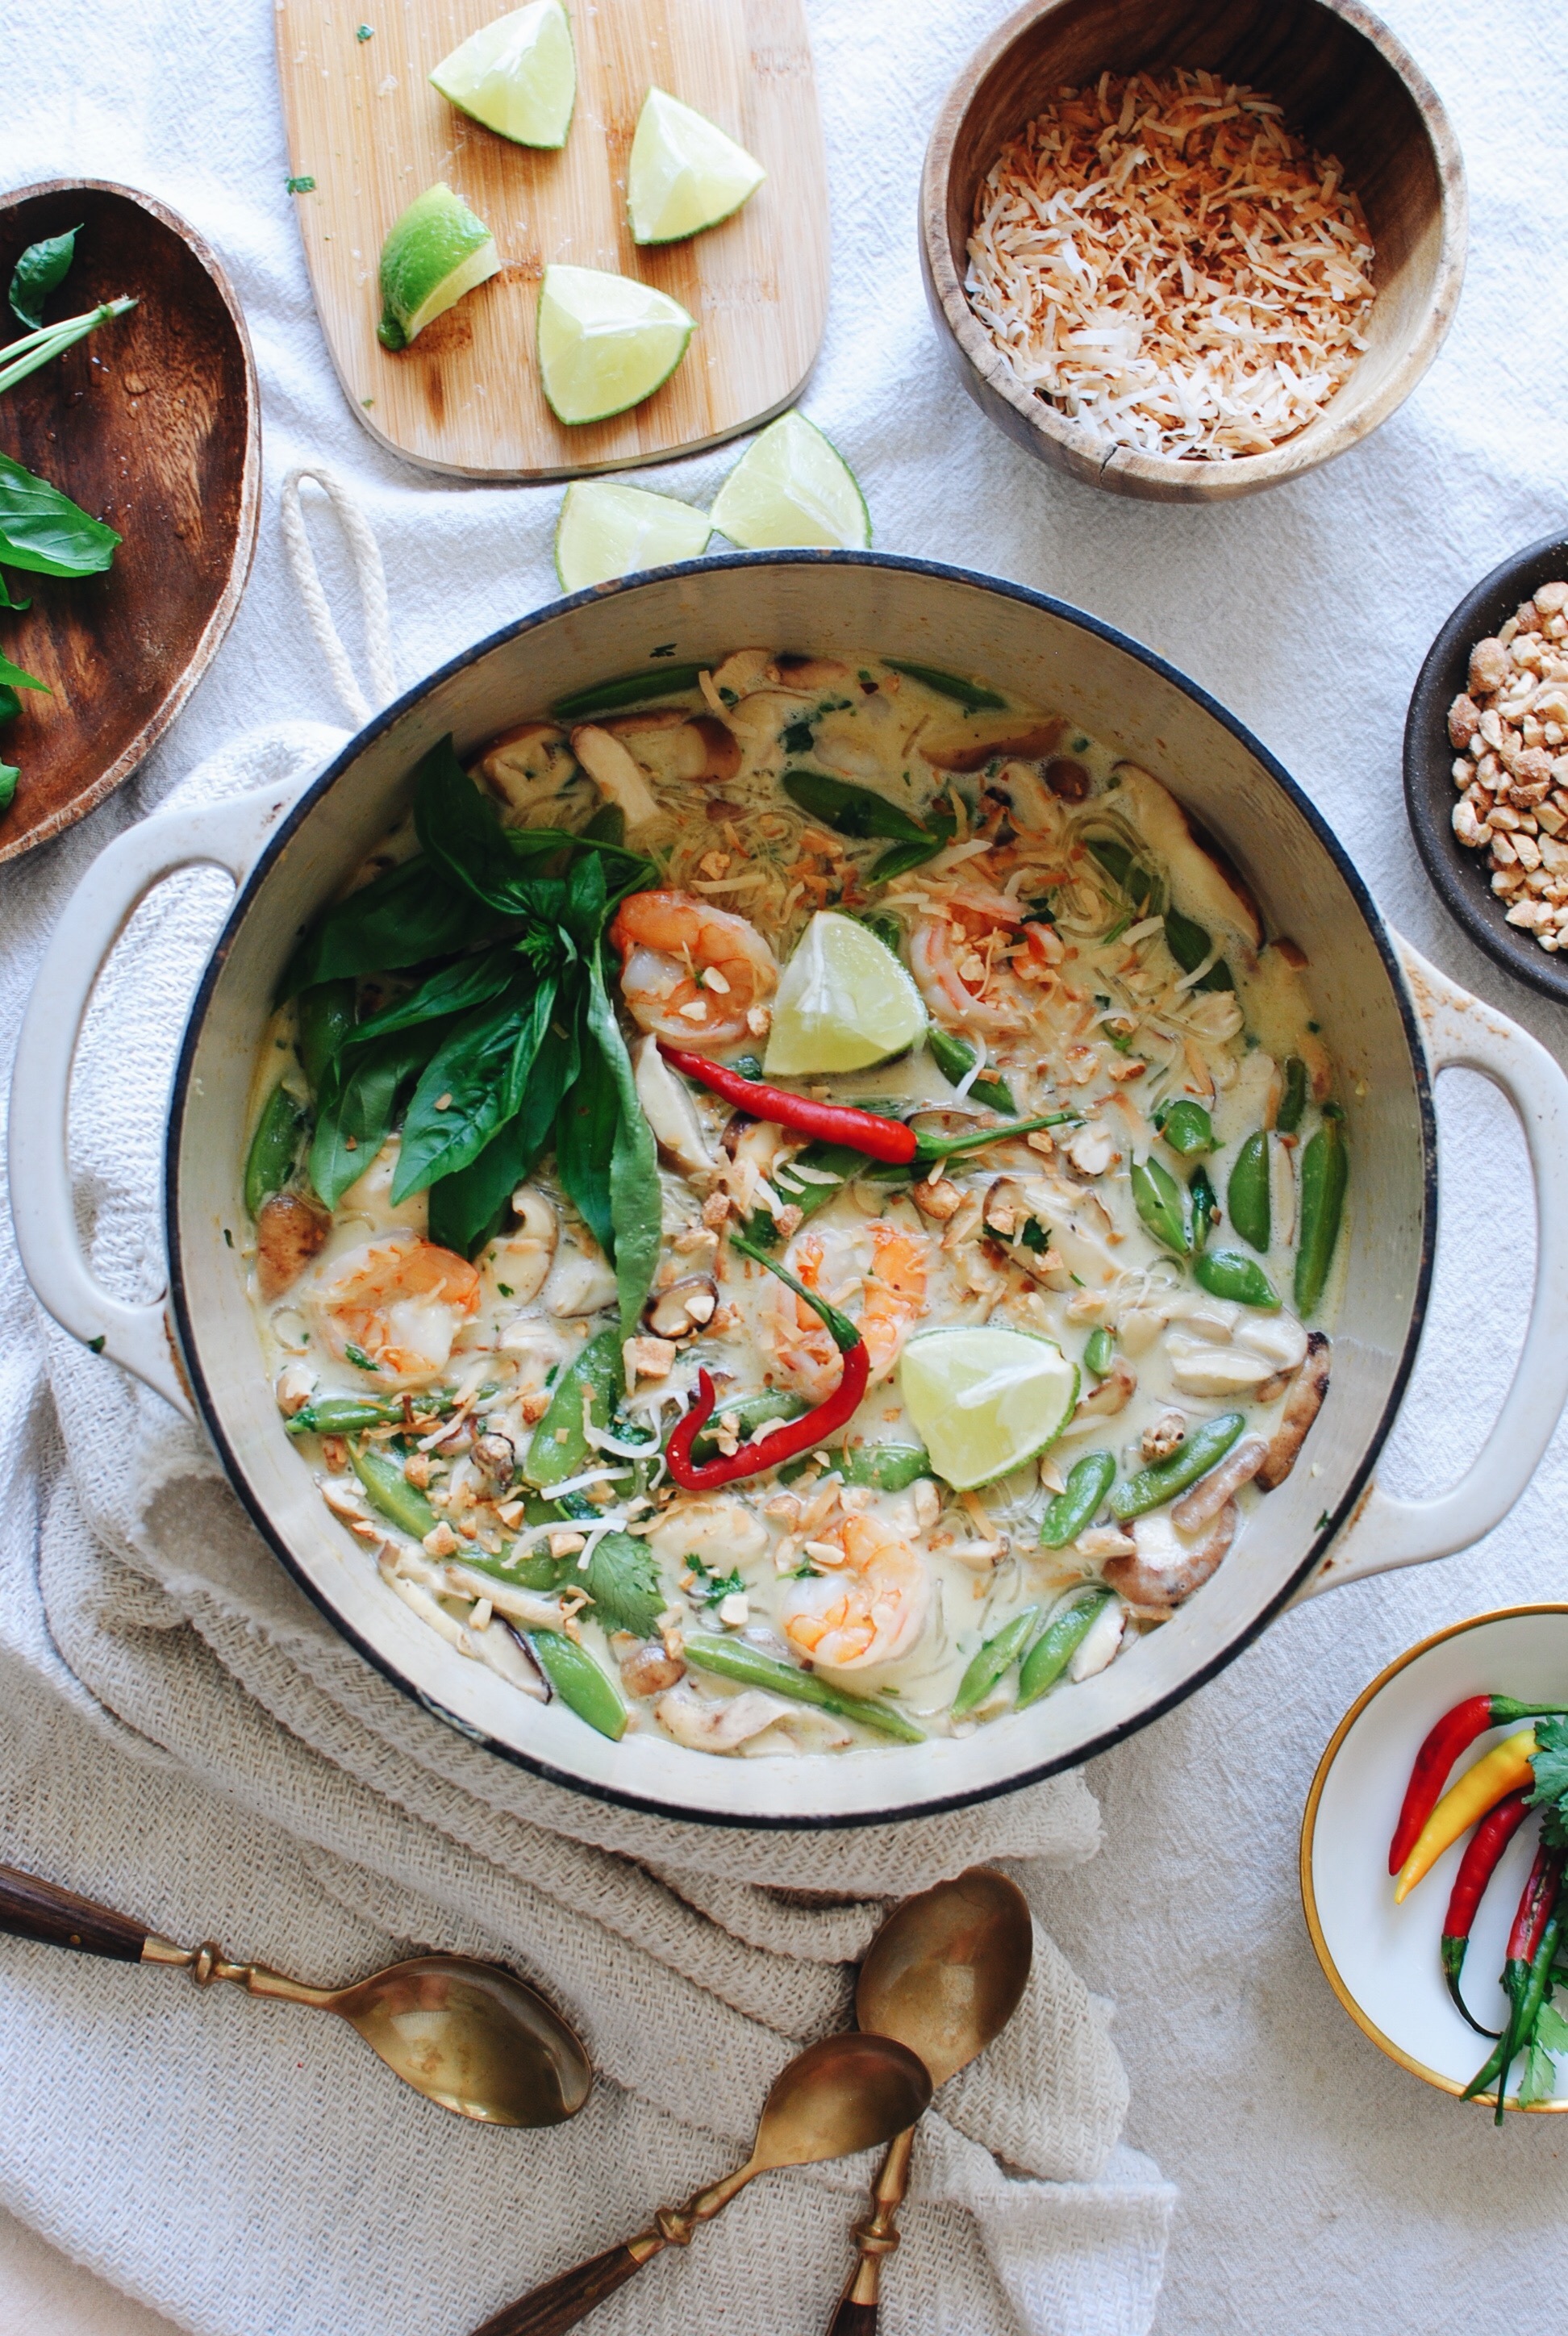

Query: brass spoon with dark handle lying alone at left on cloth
0;1867;594;2125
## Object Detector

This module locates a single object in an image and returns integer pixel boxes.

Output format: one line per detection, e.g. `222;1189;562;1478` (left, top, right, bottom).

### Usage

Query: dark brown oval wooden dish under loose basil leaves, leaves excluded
0;180;261;860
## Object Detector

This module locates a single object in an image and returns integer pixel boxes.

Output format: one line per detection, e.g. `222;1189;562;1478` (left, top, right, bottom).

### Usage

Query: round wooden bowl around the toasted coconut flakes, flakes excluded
920;0;1466;503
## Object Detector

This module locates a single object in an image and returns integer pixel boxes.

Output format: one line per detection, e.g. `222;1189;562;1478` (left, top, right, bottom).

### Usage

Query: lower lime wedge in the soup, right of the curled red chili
898;1327;1078;1493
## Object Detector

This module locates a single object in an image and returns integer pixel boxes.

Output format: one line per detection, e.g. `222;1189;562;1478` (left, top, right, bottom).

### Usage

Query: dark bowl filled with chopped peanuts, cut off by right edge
1404;530;1568;1002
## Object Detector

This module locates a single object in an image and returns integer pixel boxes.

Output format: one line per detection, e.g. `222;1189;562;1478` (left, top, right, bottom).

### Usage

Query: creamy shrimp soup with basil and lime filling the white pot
240;649;1346;1757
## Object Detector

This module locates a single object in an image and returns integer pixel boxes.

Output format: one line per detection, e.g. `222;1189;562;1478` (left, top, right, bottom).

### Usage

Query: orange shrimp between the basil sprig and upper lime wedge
610;892;778;1051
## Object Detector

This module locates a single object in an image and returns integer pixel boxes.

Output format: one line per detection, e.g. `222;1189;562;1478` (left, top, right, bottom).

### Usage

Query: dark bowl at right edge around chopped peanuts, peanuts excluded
1404;528;1568;1004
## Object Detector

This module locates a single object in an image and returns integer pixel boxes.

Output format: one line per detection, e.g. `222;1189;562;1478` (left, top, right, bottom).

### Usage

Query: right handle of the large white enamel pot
1302;934;1568;1598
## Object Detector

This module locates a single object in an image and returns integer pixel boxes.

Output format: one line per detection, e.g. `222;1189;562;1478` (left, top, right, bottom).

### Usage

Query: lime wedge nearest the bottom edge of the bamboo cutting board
540;266;696;423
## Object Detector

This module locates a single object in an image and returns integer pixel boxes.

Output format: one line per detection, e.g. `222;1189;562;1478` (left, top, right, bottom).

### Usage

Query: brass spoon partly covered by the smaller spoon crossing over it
828;1867;1035;2336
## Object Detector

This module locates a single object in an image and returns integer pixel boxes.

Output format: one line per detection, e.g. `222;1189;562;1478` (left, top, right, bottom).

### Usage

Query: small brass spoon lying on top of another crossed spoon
474;2030;930;2336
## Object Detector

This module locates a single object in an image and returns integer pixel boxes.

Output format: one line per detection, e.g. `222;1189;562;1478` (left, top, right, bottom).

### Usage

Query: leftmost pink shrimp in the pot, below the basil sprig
307;1233;479;1387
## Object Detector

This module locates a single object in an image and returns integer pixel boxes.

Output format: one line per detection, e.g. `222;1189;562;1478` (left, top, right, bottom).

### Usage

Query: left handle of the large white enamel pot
7;771;311;1420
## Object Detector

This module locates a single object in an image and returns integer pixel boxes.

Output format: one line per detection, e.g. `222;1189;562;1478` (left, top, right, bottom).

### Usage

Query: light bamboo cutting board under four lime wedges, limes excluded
276;0;828;479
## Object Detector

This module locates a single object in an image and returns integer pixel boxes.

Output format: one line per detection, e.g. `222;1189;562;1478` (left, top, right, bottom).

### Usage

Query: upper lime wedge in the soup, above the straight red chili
764;909;925;1079
